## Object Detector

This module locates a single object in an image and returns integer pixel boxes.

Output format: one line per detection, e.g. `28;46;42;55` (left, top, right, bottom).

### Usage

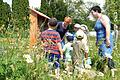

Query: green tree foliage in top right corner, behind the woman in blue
105;0;120;25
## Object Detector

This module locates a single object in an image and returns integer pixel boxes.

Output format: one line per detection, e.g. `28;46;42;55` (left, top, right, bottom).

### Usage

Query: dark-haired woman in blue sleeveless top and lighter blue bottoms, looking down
90;6;114;69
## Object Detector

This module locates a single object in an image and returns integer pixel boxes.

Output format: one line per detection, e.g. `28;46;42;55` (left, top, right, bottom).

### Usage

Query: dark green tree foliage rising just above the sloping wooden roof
37;0;68;20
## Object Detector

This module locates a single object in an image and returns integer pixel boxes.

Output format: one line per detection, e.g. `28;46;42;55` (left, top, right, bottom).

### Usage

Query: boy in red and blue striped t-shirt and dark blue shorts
41;18;62;78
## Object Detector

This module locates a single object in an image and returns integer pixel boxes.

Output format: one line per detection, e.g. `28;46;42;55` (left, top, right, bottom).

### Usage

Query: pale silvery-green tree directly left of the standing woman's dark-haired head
66;0;98;30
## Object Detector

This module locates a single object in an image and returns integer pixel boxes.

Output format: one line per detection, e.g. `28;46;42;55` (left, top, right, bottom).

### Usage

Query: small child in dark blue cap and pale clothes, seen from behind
63;34;74;74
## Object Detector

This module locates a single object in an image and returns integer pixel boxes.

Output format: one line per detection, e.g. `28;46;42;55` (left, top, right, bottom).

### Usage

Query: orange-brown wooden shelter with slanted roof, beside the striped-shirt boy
30;8;50;48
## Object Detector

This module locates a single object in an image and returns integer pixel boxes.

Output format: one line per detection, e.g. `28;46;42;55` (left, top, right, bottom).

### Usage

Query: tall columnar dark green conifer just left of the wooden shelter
12;0;29;30
